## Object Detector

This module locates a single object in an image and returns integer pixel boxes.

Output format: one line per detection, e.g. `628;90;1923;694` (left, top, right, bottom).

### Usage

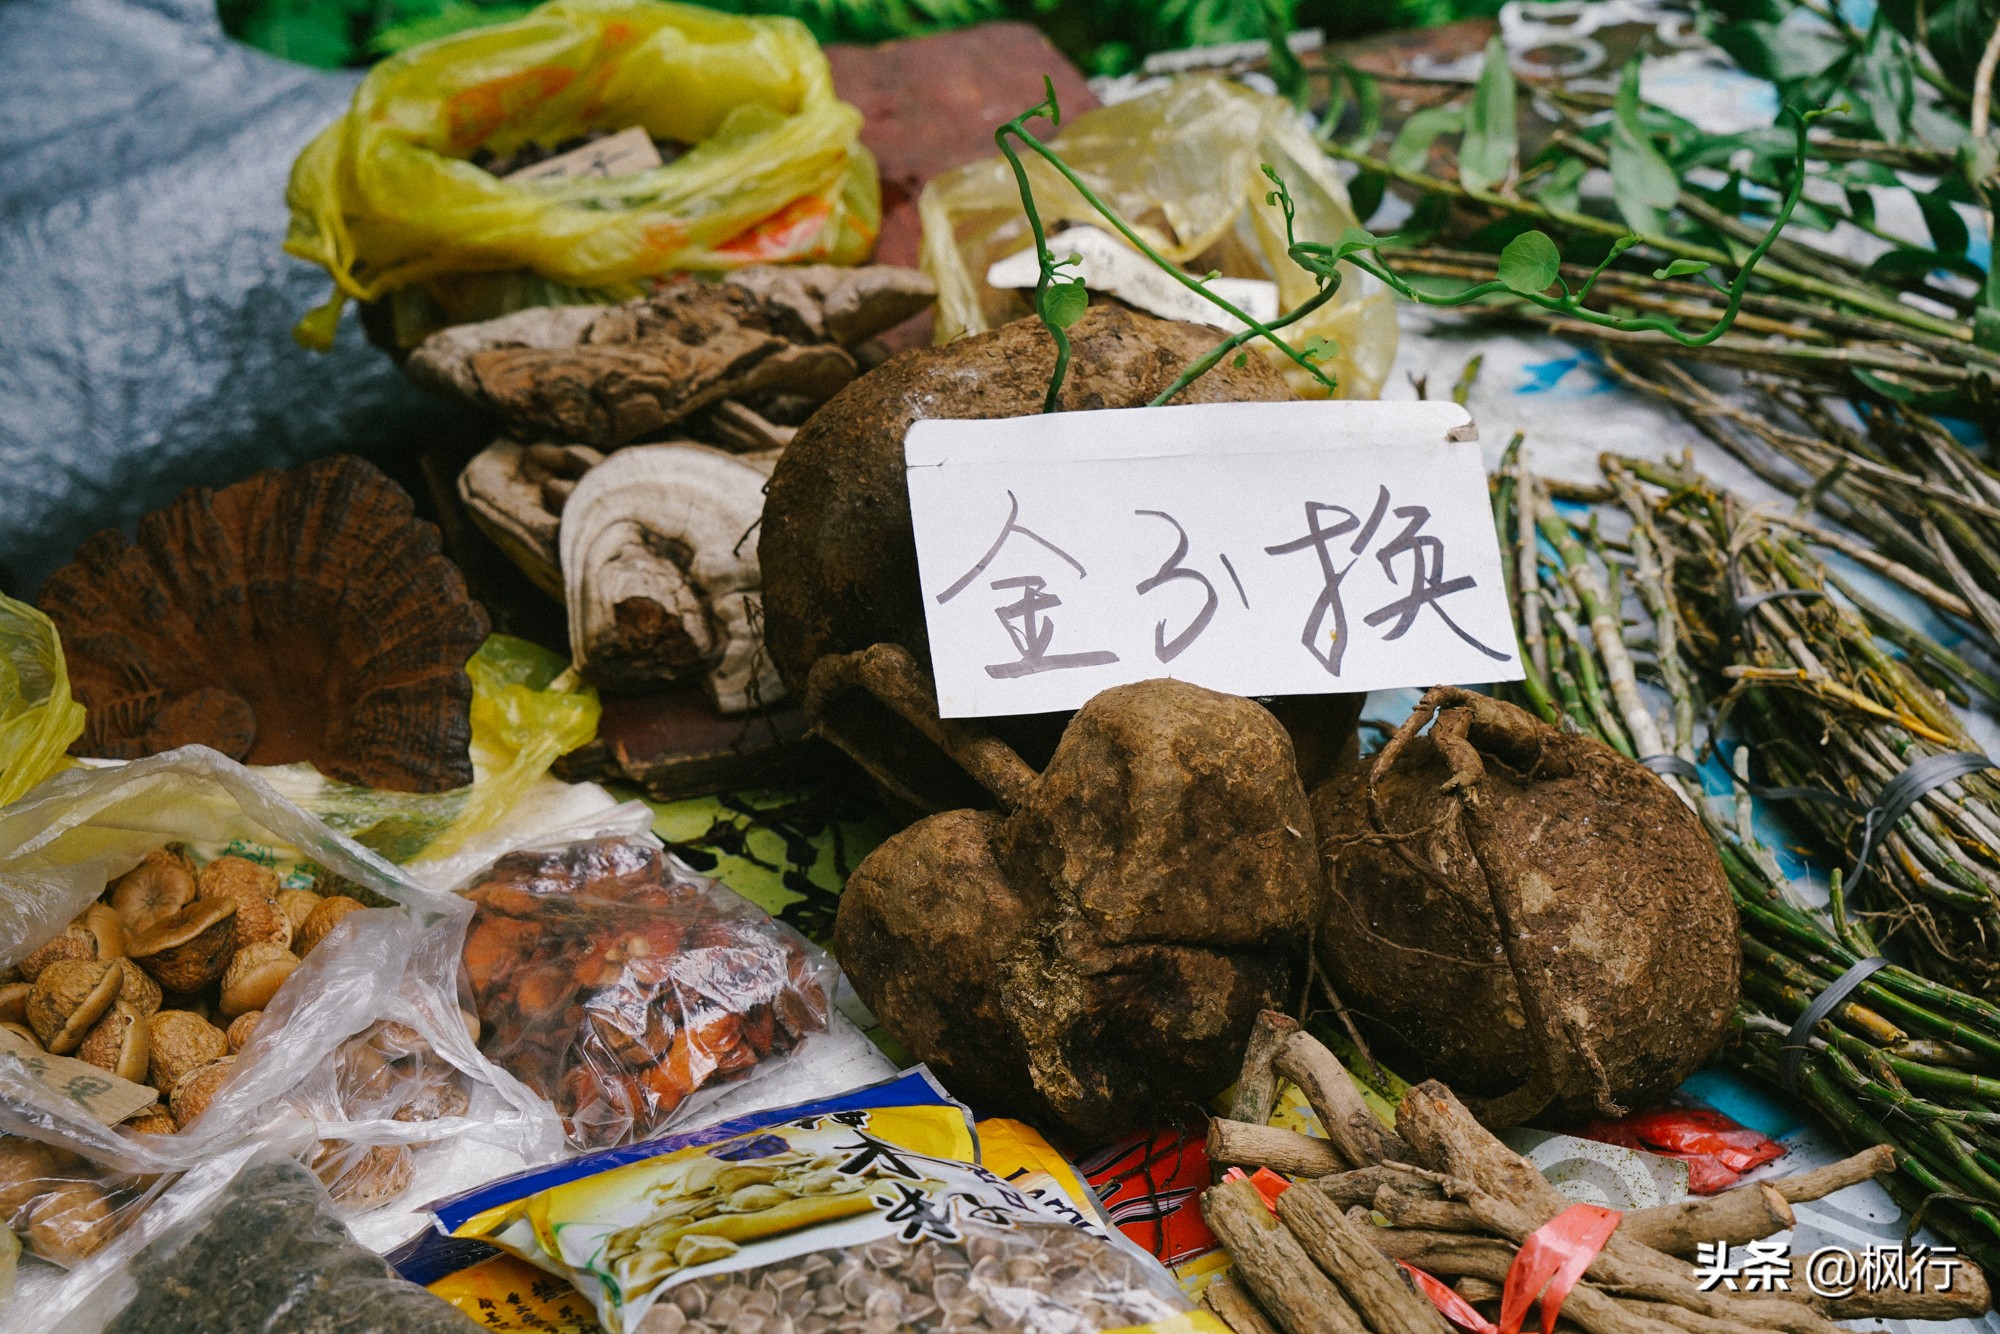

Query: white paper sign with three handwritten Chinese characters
904;402;1522;718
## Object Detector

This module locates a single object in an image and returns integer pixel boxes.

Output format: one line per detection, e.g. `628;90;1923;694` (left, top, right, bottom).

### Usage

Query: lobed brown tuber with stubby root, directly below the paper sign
810;646;1320;1138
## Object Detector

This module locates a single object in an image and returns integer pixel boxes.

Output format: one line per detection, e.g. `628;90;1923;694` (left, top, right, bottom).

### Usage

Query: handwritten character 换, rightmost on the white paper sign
1264;486;1512;676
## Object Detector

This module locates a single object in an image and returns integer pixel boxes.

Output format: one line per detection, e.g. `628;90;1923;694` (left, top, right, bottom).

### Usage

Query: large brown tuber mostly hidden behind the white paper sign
758;306;1360;810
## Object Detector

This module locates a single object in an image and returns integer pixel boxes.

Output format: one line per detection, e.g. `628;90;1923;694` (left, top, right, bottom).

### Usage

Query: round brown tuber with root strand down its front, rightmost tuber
1312;686;1738;1124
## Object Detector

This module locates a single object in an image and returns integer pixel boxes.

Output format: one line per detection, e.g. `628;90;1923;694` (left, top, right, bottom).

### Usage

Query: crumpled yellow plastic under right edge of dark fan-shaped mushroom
270;634;602;870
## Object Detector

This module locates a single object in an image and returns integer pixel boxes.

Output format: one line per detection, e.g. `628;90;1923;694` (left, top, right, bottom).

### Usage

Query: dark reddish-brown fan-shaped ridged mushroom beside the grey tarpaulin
38;456;488;792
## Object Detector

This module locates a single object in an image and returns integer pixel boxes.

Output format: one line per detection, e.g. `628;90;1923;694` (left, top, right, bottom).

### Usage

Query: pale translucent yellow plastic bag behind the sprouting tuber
918;78;1396;398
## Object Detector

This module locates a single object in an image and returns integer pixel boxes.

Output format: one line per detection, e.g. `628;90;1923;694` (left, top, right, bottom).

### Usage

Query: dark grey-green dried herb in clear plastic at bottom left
106;1156;480;1334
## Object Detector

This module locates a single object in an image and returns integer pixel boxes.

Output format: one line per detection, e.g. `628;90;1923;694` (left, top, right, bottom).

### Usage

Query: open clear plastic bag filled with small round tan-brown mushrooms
0;746;562;1288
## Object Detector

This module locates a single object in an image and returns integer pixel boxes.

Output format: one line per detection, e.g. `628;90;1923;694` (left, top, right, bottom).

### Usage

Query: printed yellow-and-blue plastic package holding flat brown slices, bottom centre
392;1070;1222;1334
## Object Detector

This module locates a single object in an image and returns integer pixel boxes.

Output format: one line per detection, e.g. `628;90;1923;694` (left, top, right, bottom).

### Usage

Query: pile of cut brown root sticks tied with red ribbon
1202;1016;1992;1334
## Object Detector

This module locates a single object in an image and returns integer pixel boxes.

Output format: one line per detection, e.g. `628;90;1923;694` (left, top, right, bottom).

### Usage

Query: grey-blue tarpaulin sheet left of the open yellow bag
0;0;450;596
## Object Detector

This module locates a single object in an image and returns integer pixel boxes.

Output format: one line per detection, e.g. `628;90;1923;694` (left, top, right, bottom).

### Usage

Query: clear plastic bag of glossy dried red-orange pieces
462;838;836;1148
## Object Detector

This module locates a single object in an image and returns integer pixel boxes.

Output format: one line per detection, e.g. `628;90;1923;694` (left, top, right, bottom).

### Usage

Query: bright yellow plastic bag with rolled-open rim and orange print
284;0;882;348
